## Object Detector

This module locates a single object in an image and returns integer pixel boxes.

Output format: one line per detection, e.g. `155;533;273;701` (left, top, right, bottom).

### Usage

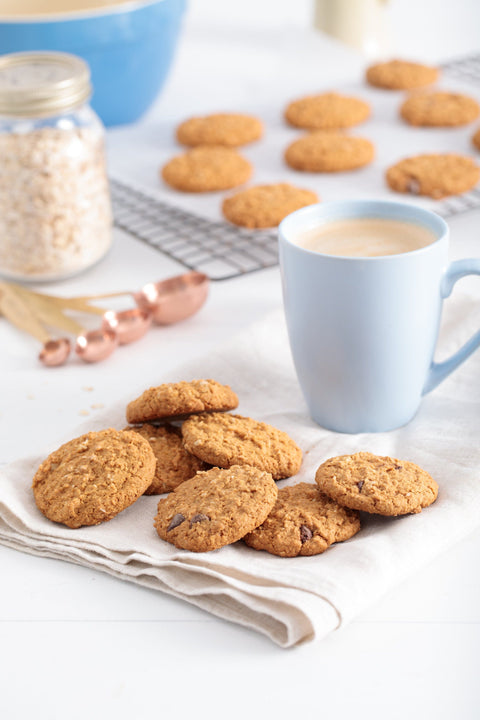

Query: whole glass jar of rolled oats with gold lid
0;52;112;281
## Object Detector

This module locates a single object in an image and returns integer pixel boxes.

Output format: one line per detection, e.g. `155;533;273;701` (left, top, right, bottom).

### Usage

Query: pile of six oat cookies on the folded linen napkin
33;380;438;557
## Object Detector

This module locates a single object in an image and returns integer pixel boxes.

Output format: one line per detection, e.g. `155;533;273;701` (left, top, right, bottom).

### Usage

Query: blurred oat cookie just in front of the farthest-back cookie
400;92;480;127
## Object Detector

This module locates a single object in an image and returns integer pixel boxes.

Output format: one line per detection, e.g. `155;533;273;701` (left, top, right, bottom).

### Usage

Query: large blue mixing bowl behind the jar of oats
0;0;185;126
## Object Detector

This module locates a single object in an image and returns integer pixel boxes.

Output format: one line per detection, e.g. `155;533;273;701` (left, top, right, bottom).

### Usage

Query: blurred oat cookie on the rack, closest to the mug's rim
222;183;318;228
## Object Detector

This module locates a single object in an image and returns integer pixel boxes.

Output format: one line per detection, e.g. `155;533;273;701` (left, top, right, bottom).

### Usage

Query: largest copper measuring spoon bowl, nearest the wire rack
133;270;210;325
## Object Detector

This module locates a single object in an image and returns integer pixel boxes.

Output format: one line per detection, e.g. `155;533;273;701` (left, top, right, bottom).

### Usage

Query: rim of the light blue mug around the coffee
278;199;448;262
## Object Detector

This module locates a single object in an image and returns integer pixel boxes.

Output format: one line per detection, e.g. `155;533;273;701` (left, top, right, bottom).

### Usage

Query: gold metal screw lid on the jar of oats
0;52;92;117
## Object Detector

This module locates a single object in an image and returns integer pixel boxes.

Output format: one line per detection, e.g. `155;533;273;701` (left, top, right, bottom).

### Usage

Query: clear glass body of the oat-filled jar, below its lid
0;105;112;281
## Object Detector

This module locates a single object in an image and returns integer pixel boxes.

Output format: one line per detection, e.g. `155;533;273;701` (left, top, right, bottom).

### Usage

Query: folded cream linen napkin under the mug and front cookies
0;298;480;647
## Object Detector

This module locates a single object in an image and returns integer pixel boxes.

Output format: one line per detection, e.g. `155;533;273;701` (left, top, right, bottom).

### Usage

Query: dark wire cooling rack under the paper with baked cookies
111;54;480;280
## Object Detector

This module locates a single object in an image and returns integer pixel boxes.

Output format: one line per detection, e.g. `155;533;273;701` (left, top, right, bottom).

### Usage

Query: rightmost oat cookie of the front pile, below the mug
315;452;438;515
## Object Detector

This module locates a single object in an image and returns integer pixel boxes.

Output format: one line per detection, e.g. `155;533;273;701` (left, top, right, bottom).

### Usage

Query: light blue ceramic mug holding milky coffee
279;200;480;433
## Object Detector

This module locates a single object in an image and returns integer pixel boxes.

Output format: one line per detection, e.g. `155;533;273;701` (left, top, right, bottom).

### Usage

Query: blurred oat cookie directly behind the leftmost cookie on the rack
177;113;263;147
